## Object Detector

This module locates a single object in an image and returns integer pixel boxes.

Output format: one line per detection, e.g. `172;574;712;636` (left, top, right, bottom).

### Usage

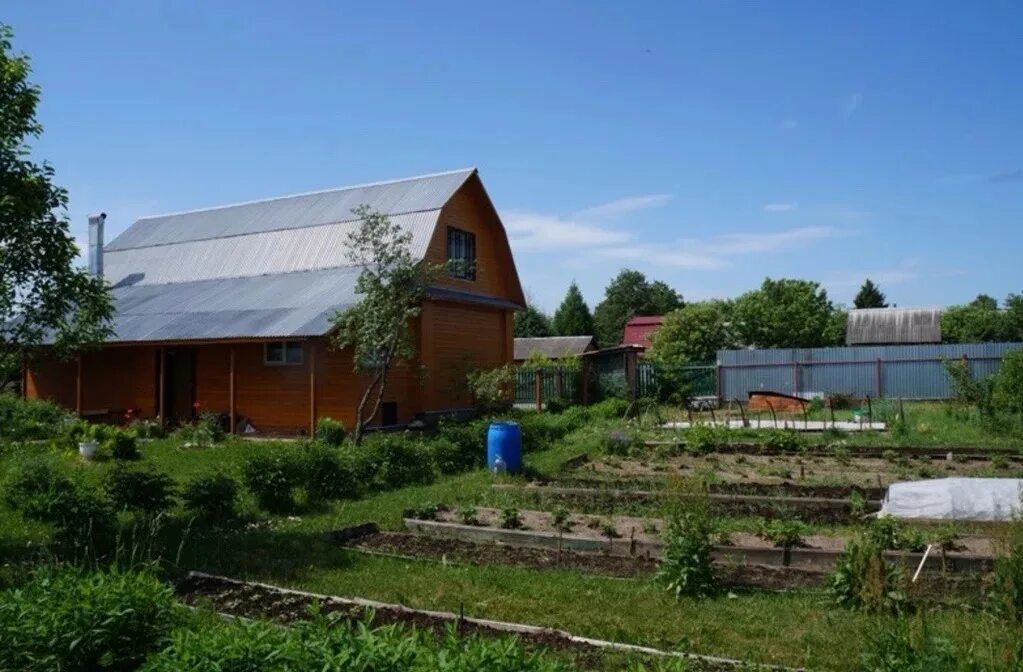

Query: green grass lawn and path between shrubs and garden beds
0;421;1023;670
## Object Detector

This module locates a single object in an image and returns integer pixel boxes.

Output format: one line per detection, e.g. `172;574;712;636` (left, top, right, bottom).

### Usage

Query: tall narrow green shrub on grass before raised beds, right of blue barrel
657;482;717;597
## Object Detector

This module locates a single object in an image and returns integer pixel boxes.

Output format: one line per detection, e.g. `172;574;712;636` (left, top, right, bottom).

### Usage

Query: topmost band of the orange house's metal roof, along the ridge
105;168;476;252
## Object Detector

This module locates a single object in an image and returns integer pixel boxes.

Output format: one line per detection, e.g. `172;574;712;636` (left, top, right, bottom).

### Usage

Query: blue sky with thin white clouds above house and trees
7;0;1023;310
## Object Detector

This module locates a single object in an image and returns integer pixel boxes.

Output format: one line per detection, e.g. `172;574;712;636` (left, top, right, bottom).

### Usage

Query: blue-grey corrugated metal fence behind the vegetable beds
717;343;1023;401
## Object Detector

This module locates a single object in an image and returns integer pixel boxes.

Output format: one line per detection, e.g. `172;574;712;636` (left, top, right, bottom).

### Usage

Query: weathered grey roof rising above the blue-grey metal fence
845;308;941;346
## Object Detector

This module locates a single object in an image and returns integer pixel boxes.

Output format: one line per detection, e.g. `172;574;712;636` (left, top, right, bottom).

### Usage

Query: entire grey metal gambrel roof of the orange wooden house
96;169;514;342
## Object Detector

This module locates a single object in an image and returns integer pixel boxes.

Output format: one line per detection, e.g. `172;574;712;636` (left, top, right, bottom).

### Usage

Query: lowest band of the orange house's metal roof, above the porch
108;268;360;343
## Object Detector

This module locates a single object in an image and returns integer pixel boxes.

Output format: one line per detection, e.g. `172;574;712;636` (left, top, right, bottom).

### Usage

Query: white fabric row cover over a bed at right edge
881;478;1023;521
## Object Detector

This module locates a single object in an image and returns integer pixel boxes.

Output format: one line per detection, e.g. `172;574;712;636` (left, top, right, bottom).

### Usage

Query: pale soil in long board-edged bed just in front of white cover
427;507;994;556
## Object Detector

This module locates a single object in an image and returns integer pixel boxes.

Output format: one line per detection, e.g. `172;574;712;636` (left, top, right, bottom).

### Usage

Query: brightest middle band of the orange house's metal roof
104;210;440;285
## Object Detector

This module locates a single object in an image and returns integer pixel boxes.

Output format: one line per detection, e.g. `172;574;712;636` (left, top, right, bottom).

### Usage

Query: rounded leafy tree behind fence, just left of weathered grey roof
733;278;835;348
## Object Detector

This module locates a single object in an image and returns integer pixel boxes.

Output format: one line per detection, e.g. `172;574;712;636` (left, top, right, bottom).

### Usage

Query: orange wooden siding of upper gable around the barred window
427;173;525;304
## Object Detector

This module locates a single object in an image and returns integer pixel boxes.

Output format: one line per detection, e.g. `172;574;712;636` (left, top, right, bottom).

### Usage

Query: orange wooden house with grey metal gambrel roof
27;169;525;433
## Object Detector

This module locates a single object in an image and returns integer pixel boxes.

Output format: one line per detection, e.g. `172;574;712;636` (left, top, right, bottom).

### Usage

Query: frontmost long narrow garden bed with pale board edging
177;572;786;672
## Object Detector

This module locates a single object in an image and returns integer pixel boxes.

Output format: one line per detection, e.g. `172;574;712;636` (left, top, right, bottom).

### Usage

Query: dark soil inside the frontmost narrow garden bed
177;574;752;672
